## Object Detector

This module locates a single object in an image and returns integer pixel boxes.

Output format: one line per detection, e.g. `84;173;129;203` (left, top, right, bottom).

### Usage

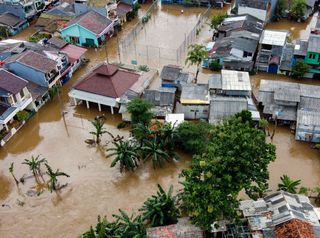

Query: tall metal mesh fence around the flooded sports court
121;6;211;67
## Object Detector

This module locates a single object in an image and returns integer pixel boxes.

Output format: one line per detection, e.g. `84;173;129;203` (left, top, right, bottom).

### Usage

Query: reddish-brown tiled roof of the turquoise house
68;11;112;34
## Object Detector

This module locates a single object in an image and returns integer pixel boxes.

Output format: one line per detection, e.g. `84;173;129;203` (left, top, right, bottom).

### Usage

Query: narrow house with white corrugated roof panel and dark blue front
255;30;288;74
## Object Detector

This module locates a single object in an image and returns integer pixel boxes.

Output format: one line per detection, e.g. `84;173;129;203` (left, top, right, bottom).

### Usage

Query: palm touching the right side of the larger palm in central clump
141;136;170;169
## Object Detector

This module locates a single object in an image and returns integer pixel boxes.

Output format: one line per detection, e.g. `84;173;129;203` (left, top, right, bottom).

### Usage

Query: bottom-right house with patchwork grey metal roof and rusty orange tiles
239;191;320;238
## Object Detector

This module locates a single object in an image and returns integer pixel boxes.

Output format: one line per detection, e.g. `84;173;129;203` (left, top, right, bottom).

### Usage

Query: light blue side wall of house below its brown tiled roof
4;62;48;87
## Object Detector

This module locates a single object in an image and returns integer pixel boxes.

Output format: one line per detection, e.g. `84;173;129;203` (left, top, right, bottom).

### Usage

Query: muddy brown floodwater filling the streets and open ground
0;1;320;238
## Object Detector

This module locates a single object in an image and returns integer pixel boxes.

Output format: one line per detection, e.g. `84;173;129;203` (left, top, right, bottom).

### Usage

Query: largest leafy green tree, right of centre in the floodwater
180;117;276;230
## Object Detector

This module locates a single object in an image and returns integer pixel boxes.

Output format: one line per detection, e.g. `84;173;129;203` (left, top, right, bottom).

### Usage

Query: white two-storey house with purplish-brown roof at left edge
0;69;32;131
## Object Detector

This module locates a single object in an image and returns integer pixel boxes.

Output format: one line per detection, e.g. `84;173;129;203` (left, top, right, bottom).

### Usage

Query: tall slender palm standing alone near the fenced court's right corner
186;44;208;83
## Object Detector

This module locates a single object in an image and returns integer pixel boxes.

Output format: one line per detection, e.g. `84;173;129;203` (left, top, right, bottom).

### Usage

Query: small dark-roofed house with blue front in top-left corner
0;12;29;36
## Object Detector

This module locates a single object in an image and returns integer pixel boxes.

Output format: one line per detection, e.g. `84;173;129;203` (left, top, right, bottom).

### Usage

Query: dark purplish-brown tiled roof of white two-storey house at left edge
0;69;28;94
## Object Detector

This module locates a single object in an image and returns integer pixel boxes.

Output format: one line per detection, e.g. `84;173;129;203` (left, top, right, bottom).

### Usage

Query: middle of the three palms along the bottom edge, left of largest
112;209;147;238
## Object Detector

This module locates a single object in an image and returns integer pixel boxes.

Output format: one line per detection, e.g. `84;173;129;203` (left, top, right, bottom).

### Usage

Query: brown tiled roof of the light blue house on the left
17;50;56;73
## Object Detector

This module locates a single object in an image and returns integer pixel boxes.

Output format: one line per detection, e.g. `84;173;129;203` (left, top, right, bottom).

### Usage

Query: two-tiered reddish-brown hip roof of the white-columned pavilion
74;64;140;98
